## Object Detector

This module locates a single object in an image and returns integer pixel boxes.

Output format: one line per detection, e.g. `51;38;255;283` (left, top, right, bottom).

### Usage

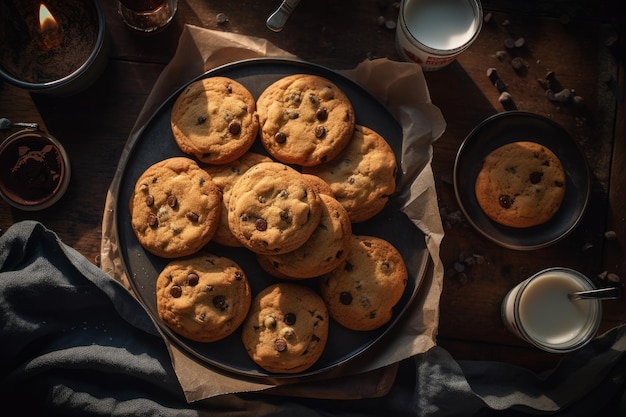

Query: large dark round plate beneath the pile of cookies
115;59;430;378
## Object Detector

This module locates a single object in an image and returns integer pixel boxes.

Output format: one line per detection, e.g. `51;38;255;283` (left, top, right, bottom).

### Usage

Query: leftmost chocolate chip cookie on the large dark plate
129;157;222;258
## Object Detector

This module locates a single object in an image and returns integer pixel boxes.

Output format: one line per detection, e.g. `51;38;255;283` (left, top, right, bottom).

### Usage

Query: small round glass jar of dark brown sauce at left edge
0;129;71;211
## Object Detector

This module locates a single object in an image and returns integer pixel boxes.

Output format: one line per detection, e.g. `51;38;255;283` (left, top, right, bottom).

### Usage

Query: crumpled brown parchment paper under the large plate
101;25;446;402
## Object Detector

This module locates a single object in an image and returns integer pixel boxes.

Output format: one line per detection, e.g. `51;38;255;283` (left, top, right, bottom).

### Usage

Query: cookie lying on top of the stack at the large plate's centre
228;162;322;255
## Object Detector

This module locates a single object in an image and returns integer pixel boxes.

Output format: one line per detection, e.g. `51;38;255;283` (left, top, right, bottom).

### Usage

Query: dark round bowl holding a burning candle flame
0;0;108;95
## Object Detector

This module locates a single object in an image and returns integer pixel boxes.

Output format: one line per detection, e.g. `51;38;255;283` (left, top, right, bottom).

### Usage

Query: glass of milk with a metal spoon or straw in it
502;267;602;353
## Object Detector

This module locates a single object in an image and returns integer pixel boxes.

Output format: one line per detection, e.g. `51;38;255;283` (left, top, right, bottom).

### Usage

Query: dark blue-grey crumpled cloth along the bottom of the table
0;221;626;417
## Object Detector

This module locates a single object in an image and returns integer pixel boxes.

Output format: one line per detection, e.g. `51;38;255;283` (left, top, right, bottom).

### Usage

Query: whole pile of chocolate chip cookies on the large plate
130;74;408;373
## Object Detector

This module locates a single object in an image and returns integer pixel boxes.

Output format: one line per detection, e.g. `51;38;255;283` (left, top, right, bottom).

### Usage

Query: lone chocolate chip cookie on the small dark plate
475;141;566;228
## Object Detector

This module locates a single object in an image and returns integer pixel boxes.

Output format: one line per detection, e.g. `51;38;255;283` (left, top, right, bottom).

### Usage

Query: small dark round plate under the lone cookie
454;111;591;250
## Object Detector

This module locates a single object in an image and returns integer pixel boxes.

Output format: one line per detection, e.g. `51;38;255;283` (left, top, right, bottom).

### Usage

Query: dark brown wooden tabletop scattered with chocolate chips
0;0;626;370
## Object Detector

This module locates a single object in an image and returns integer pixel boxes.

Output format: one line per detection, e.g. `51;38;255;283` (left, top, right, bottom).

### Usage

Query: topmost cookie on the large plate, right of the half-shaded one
257;74;355;166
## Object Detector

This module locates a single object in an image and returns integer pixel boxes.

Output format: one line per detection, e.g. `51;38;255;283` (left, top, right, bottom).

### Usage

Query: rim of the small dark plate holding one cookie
452;110;591;251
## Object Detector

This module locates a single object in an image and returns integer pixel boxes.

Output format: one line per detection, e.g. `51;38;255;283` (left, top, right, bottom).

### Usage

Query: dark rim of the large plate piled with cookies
113;57;432;381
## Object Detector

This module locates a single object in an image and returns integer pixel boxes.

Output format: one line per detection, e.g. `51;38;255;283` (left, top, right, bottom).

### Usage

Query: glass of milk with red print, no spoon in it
396;0;483;71
